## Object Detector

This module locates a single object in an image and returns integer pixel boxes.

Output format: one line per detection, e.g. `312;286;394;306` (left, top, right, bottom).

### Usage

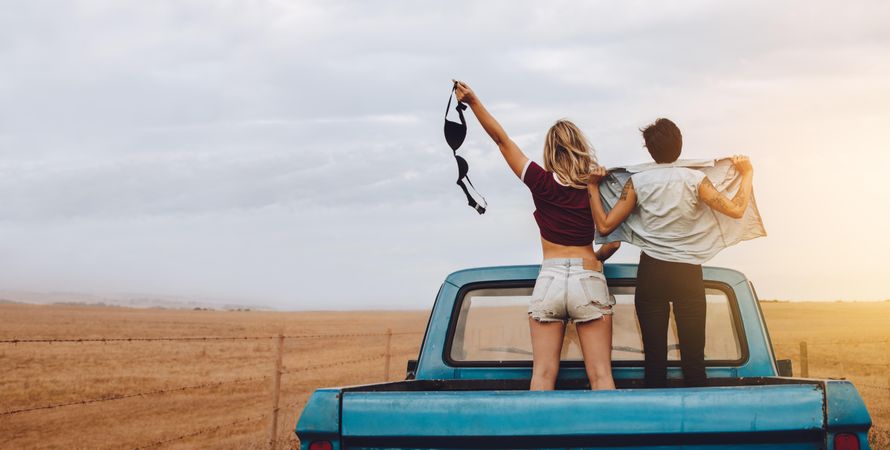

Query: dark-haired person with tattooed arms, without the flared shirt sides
587;118;754;388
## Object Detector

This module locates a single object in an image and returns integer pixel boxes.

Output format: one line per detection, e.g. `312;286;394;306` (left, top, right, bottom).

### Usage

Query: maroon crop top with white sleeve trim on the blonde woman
522;160;594;246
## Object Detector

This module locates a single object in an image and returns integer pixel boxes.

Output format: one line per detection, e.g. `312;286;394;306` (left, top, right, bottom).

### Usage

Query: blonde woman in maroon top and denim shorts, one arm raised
455;81;618;390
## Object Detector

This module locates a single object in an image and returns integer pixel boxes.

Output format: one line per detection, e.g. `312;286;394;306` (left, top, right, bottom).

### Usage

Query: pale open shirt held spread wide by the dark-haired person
596;158;766;264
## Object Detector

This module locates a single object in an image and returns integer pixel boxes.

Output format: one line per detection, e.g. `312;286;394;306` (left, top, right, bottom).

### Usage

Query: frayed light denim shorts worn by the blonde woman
528;258;615;323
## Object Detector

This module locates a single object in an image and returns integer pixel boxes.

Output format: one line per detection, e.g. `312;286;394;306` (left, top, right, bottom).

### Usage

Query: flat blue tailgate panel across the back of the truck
341;384;824;449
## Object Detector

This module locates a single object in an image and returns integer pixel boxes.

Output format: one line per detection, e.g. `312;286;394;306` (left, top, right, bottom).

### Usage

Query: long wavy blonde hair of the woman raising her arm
544;119;596;189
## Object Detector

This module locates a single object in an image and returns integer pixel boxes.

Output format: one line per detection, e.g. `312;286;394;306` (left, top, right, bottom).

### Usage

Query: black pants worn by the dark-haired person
634;253;707;388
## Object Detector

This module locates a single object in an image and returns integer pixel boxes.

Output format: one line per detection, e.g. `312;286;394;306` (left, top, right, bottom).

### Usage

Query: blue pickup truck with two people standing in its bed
296;264;871;450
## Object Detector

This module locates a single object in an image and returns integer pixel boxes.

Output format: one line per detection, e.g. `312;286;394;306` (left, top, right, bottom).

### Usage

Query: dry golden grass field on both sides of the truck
0;302;890;448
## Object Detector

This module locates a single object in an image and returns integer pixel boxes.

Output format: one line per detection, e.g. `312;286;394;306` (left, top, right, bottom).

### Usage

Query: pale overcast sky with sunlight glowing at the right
0;0;890;309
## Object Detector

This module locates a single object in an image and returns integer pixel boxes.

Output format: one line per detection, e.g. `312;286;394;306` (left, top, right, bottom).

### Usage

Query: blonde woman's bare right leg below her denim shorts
575;315;615;390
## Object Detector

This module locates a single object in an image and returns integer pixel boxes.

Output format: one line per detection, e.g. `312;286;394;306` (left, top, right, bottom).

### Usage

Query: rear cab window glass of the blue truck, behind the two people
446;280;747;366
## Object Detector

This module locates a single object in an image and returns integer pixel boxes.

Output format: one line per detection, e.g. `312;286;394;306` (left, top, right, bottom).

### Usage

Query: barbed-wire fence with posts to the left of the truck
0;330;422;449
